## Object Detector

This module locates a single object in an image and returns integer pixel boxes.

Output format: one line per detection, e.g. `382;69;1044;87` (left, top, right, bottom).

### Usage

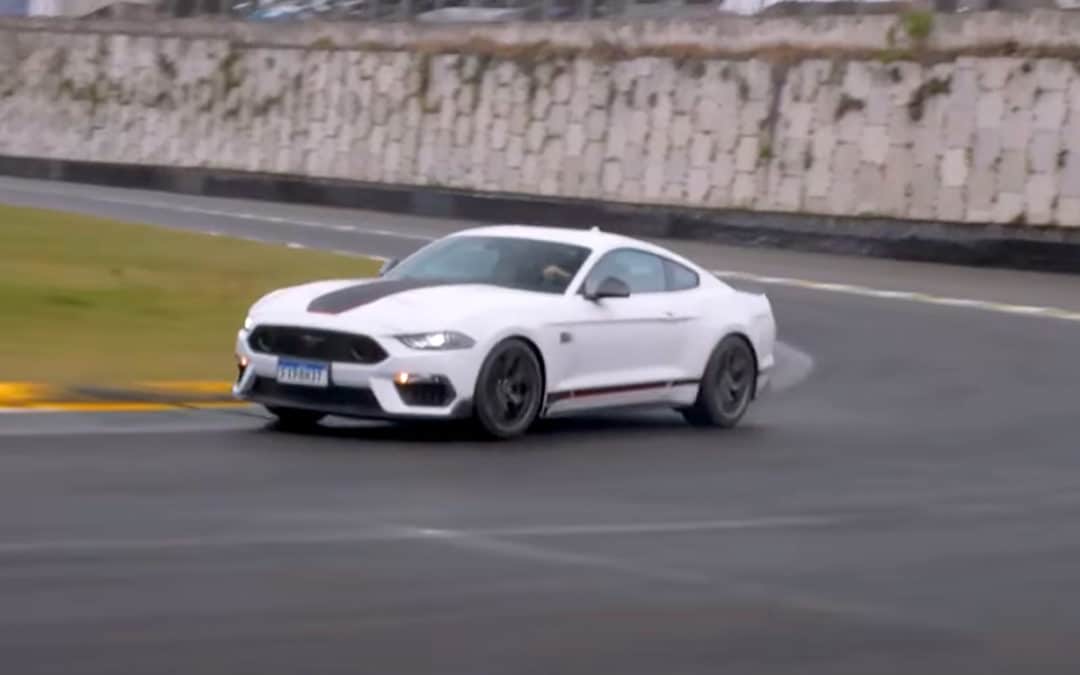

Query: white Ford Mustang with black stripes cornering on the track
233;226;775;438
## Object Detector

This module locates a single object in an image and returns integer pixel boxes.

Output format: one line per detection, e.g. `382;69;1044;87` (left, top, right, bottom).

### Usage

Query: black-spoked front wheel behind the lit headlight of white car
473;338;543;440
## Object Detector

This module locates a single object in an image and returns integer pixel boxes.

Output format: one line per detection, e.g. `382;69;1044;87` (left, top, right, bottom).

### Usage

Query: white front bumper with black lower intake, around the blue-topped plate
232;330;482;419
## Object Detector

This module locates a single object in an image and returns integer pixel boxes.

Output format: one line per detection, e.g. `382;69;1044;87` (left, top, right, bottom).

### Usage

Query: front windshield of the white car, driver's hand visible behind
386;235;591;293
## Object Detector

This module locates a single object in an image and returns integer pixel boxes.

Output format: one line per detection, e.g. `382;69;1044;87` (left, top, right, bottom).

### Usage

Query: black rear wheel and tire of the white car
683;335;757;429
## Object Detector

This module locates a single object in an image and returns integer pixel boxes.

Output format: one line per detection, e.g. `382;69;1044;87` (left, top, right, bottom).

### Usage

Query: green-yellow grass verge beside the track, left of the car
0;205;378;386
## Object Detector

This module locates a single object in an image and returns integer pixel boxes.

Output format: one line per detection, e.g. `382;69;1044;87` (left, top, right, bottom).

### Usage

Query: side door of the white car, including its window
550;248;685;411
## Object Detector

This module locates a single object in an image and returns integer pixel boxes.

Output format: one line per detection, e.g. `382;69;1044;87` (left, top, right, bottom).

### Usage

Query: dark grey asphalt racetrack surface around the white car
6;180;1080;675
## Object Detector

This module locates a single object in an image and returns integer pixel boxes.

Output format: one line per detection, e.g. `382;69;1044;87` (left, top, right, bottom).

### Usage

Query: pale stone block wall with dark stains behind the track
0;11;1080;227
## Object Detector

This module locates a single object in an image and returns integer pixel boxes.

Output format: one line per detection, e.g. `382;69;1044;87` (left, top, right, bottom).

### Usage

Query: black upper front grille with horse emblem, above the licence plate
247;326;388;364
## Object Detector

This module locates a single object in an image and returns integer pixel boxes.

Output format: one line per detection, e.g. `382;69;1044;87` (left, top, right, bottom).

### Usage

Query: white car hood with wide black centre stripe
251;279;558;335
